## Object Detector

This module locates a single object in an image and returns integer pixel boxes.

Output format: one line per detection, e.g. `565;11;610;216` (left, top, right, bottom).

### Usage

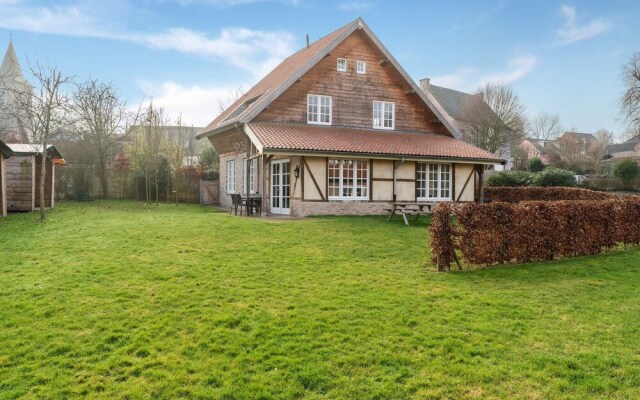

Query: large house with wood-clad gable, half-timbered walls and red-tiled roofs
198;18;502;216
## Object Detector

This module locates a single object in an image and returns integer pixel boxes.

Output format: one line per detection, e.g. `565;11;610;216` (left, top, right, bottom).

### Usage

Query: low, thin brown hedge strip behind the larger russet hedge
484;186;617;202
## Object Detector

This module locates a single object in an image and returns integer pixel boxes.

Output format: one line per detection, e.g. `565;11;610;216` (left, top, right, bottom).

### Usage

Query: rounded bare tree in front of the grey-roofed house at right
462;83;527;153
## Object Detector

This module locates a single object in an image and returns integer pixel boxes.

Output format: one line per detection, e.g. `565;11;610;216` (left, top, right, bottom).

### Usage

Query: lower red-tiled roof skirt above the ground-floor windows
248;122;501;162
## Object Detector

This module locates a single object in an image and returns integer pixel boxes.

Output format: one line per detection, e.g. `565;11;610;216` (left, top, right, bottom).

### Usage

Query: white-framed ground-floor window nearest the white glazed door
328;159;369;200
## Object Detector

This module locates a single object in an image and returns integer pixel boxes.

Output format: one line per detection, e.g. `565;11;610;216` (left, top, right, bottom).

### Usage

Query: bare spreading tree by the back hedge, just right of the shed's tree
72;79;140;198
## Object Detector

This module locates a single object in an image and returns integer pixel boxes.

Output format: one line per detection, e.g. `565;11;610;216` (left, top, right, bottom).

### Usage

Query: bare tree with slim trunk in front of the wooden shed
13;64;72;221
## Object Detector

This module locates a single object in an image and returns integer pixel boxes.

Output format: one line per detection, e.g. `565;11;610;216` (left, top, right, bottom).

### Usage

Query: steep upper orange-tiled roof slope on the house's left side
203;20;358;132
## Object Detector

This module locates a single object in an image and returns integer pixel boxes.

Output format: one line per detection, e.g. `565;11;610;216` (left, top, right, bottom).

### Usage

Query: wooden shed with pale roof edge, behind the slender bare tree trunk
5;144;65;211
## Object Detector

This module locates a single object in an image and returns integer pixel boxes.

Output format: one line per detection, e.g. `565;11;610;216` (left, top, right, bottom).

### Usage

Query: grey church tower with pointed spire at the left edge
0;40;32;142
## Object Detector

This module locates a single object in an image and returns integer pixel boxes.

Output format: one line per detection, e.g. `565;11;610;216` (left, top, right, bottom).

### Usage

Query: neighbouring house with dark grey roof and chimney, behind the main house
420;78;512;170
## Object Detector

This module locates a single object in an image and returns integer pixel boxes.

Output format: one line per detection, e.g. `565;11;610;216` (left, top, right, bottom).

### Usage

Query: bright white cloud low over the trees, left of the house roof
139;81;246;127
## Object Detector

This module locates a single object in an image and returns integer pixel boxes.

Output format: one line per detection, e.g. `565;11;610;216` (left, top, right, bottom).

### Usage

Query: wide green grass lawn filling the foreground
0;202;640;399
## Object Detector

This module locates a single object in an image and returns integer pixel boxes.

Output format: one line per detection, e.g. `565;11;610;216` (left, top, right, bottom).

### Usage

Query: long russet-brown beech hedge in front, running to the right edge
429;196;640;271
